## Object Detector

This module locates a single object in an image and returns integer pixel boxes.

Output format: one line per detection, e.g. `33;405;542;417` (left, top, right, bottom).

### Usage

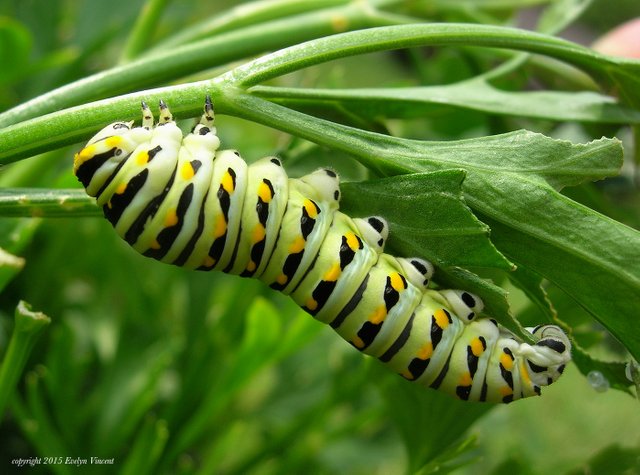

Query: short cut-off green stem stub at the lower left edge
0;301;51;414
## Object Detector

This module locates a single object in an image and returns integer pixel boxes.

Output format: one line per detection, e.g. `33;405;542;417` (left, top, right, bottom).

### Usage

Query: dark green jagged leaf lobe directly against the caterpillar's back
340;170;512;269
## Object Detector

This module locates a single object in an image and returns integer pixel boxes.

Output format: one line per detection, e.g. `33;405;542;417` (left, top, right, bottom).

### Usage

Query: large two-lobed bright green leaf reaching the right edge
336;132;640;357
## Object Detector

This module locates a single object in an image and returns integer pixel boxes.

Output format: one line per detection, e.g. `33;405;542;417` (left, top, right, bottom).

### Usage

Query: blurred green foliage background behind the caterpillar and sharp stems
0;0;640;474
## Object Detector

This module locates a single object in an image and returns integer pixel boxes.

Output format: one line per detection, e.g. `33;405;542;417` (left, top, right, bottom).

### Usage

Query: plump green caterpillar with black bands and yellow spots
74;97;571;402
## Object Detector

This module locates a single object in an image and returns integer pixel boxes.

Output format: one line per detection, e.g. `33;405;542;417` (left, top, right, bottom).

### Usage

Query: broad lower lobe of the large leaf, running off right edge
482;199;640;359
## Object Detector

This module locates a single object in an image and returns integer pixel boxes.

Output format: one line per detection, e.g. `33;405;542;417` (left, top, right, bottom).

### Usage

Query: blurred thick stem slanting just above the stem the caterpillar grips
0;0;398;128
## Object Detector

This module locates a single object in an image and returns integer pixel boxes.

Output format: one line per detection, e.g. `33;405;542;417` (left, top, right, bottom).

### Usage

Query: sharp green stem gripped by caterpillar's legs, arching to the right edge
5;23;640;164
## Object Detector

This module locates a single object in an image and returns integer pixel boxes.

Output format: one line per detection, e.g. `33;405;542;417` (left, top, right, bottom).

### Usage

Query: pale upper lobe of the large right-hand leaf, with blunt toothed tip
398;130;622;190
